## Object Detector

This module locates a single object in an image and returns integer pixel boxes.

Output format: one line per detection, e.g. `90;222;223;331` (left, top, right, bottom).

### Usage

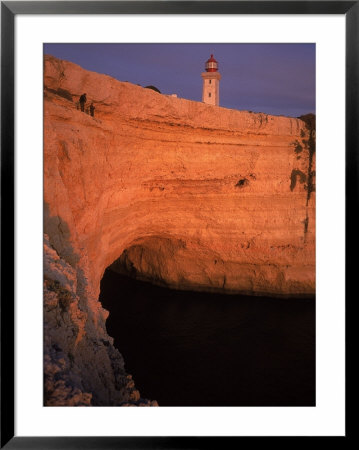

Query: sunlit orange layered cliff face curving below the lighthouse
44;56;315;404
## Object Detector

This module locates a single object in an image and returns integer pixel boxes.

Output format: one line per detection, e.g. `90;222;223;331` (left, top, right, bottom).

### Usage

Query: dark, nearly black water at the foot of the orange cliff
100;270;315;406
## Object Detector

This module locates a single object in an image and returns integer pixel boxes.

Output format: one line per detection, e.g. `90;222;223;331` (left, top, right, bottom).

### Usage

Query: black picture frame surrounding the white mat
0;1;359;449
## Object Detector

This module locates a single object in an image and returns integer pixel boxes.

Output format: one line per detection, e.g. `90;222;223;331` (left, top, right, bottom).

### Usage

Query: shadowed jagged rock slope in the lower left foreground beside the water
44;235;156;406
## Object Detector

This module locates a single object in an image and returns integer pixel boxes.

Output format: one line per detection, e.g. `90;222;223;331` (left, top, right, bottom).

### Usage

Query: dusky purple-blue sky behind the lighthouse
44;44;315;117
